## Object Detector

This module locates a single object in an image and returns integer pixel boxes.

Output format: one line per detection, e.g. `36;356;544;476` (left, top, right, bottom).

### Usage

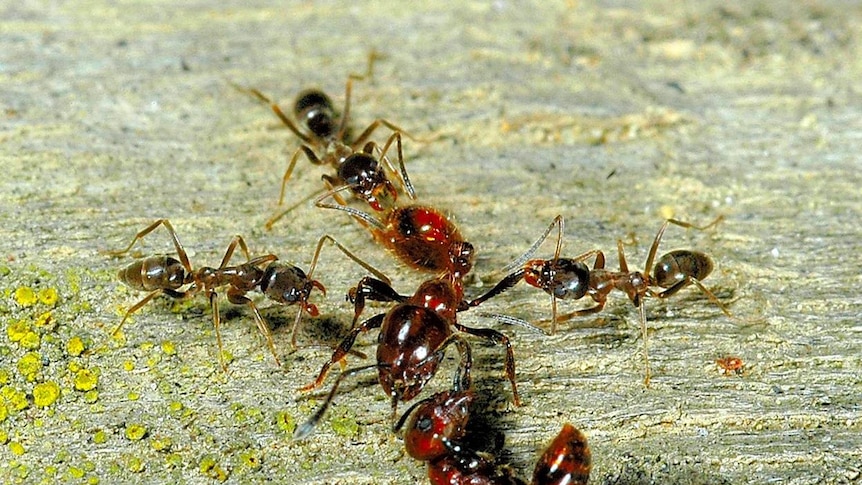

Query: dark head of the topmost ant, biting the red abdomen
338;153;398;211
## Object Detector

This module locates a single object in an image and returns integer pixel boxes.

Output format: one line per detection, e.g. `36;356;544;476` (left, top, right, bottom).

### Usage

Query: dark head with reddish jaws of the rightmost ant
524;258;590;300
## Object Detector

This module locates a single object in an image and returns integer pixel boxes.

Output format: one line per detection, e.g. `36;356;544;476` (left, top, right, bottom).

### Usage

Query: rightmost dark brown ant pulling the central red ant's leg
467;216;733;387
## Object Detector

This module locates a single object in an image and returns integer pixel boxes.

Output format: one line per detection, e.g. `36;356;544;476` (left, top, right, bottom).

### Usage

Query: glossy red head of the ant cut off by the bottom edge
404;391;474;461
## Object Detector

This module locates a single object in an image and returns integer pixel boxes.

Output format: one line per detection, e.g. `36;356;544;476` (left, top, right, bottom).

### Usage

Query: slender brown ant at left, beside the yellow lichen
106;219;379;371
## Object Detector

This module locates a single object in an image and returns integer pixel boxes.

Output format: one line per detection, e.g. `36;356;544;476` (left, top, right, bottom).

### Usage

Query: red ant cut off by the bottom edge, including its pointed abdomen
395;381;591;485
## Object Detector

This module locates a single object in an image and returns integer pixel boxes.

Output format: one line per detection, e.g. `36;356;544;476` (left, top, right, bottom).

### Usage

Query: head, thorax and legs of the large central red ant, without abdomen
294;275;521;439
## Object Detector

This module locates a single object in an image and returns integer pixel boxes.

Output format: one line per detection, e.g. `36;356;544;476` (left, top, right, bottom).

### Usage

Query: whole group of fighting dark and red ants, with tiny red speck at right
101;69;742;485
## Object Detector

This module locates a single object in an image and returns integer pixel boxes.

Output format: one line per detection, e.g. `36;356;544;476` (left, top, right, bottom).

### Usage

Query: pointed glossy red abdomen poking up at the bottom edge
532;423;592;485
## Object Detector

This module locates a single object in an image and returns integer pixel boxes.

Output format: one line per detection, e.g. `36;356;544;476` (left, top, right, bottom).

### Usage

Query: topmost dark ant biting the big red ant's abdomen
234;75;415;229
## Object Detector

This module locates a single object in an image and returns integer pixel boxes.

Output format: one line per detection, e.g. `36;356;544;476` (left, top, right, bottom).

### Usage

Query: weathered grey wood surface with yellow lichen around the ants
0;0;862;484
